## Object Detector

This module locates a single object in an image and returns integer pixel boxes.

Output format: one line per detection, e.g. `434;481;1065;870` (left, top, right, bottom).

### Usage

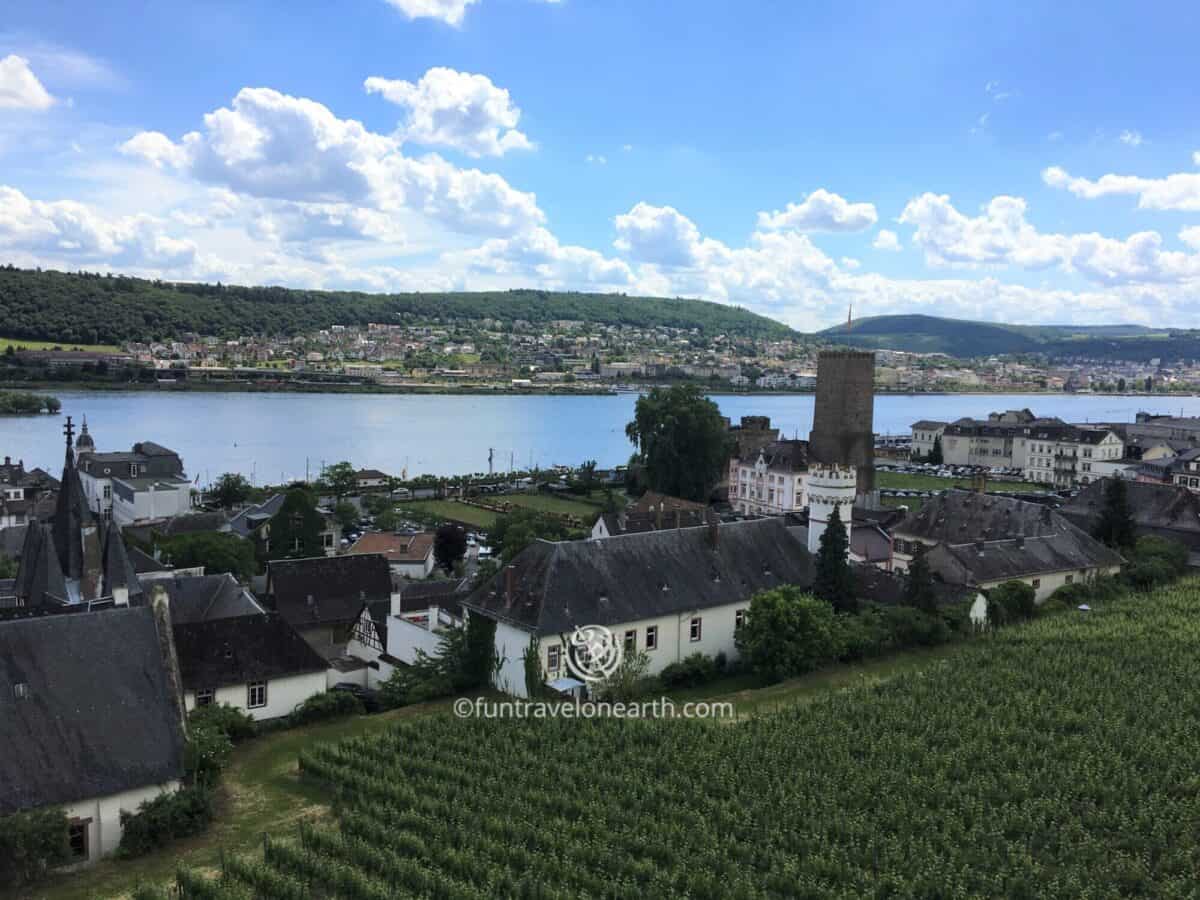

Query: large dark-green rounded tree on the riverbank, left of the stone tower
625;384;732;500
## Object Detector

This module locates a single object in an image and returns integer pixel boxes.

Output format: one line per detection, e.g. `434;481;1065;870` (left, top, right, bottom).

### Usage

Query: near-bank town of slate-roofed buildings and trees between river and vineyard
0;348;1200;892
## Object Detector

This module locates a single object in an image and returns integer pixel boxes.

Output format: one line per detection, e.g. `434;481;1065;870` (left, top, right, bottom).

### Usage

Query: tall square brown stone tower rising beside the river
809;350;875;494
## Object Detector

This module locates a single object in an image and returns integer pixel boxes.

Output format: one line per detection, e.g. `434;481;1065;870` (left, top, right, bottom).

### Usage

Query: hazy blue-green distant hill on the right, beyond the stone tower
815;316;1200;361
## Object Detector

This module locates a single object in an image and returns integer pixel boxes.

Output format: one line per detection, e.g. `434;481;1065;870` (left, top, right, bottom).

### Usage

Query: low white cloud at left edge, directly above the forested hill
0;186;196;269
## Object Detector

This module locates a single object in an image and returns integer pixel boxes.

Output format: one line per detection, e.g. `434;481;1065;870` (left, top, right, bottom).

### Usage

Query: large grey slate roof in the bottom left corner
0;606;184;815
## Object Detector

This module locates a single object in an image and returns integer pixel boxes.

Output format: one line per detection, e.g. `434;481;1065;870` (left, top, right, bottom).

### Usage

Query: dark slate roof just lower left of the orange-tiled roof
266;553;391;628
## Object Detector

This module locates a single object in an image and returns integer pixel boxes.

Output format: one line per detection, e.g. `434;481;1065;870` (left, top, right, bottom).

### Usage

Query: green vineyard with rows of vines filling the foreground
162;581;1200;900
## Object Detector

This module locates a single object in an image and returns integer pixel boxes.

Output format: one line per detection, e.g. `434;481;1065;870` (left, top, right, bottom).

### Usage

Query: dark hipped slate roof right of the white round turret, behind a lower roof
893;490;1064;544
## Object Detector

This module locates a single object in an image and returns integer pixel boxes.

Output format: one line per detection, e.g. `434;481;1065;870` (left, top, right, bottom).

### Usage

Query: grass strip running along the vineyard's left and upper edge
28;644;961;900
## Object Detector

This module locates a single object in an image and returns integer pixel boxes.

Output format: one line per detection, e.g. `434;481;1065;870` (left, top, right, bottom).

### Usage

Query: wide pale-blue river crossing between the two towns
0;391;1200;485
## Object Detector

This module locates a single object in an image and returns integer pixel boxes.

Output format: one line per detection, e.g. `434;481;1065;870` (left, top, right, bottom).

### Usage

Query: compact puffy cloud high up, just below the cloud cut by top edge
364;67;533;157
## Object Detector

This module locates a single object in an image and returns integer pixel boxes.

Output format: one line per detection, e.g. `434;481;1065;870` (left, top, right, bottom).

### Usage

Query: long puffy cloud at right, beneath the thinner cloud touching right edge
900;193;1200;284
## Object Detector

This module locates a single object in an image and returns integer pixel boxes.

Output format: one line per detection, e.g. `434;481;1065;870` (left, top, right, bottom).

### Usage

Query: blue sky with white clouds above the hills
0;0;1200;330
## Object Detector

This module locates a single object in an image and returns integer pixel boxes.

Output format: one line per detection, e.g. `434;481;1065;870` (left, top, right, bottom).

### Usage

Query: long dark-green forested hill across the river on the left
0;266;797;343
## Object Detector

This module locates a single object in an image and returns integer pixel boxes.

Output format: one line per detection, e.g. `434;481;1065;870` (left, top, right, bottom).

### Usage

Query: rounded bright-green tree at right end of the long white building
734;584;841;682
